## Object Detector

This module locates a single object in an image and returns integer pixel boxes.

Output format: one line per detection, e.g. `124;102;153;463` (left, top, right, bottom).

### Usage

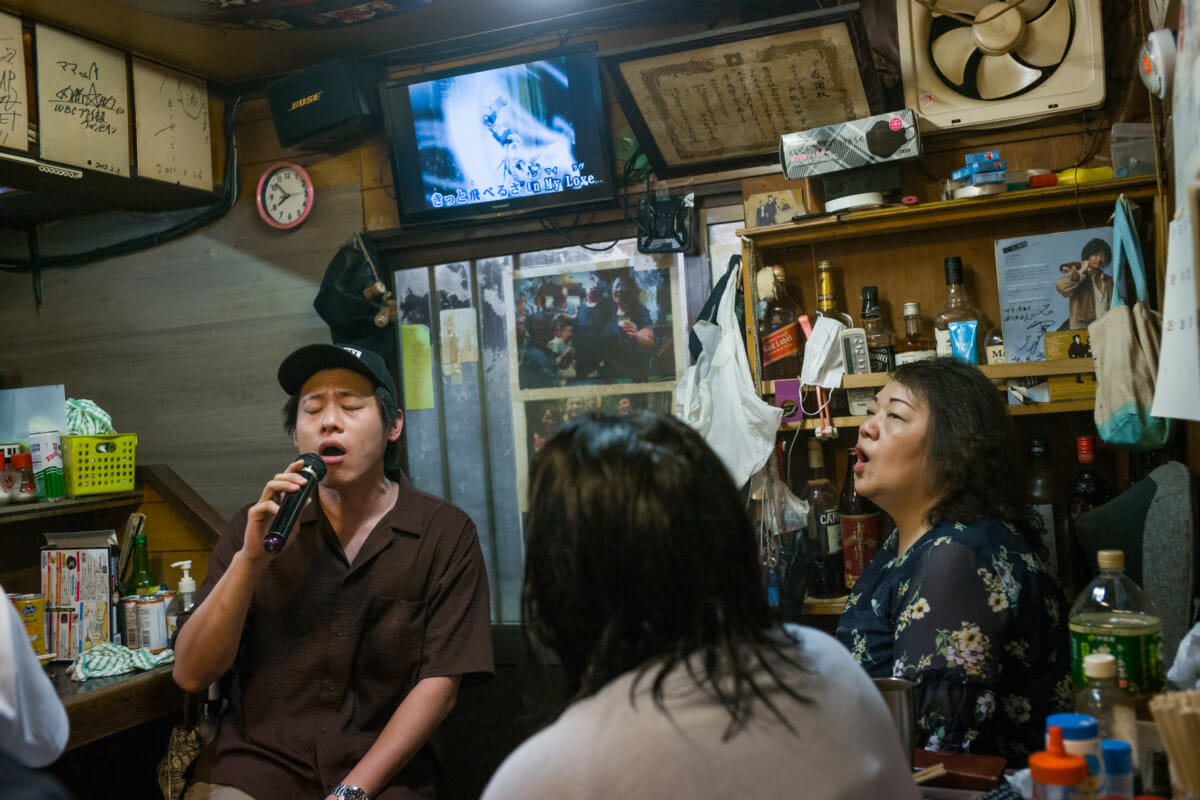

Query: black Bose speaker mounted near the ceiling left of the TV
266;59;383;152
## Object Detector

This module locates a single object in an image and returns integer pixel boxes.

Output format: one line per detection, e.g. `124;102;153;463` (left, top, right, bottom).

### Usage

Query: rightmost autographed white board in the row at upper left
133;59;212;192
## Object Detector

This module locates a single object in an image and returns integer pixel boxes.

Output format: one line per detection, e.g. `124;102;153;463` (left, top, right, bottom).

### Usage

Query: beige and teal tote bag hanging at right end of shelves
1087;194;1170;450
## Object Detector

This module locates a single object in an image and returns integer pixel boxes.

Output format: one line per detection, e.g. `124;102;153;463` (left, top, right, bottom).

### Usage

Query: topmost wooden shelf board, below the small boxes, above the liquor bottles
737;175;1158;248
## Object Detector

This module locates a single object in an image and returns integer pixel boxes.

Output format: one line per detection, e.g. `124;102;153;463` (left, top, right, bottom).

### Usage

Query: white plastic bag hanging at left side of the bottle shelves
672;265;784;486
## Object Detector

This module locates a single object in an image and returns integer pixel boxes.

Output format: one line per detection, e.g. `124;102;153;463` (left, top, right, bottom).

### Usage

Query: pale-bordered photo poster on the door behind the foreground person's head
506;251;688;504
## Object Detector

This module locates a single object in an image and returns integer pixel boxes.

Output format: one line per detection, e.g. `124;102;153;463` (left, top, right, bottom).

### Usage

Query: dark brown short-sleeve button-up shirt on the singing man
180;475;493;800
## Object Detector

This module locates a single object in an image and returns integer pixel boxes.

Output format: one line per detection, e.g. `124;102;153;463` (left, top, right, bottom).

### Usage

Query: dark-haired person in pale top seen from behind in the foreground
484;411;919;800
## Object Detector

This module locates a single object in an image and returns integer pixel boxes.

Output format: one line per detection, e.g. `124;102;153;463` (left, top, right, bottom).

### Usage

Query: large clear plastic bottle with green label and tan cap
1068;551;1163;703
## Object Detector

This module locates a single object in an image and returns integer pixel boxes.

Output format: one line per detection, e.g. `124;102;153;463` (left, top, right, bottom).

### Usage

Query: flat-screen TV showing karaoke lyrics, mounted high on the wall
380;46;617;227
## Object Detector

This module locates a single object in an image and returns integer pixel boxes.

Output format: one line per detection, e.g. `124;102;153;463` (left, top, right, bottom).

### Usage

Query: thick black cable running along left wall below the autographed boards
0;95;241;275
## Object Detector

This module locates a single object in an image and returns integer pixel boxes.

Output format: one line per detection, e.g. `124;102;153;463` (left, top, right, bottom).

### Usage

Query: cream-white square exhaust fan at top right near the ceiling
896;0;1104;133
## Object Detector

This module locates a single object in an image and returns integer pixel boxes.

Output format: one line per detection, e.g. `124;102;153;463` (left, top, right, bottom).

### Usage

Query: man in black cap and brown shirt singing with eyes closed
174;344;492;800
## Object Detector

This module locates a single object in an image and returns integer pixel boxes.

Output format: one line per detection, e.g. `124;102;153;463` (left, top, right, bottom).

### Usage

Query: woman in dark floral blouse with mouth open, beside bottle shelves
836;359;1073;766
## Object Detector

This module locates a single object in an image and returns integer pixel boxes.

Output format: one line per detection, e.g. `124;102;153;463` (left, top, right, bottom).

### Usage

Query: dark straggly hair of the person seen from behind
522;411;805;738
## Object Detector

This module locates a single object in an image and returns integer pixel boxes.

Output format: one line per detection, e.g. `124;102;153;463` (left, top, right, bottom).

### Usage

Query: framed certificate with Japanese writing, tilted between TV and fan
599;4;887;178
